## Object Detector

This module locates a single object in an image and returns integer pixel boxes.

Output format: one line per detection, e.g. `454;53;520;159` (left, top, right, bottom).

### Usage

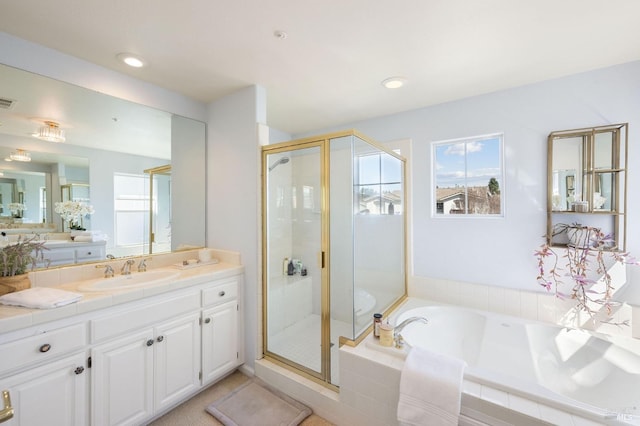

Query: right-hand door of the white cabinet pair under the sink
154;312;200;410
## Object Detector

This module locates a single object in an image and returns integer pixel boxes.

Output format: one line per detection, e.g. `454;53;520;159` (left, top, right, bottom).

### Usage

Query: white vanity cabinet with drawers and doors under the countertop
0;270;244;426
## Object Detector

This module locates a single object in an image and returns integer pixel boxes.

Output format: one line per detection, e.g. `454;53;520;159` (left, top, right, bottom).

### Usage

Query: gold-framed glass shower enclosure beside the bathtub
262;131;406;387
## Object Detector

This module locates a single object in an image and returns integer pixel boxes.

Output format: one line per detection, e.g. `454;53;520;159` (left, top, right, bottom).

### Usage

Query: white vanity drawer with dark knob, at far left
0;324;87;374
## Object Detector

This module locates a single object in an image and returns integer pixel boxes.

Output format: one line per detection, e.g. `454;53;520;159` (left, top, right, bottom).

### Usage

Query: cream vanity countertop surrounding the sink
0;261;244;336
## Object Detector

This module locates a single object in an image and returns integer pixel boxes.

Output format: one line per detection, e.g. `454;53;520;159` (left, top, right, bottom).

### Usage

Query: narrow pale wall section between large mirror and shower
207;86;266;368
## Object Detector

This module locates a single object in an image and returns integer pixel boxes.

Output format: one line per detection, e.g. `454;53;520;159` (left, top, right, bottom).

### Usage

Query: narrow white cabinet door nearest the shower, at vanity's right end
202;300;238;384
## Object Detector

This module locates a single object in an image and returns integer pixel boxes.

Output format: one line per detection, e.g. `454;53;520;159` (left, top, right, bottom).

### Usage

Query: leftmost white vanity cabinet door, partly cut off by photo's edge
0;353;88;426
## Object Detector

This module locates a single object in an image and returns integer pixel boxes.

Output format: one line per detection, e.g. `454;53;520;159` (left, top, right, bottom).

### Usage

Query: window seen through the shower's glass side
354;152;403;215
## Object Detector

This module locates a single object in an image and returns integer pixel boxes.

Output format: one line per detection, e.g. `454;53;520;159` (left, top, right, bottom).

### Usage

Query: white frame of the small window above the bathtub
430;132;506;219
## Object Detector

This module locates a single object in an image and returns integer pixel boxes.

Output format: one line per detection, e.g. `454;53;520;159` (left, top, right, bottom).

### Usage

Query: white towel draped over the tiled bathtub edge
397;347;467;426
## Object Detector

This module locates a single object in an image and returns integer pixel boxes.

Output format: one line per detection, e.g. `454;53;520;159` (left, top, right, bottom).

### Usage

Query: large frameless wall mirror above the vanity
0;64;206;266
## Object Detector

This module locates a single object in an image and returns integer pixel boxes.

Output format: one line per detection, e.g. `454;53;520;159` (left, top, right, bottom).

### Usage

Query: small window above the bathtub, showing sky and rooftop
432;134;504;217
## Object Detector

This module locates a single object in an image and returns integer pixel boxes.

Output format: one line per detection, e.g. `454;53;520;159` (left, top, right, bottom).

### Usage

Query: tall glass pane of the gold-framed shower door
264;144;324;378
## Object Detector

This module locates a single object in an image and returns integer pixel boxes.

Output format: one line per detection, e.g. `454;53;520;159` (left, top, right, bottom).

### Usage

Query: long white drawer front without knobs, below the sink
91;292;200;342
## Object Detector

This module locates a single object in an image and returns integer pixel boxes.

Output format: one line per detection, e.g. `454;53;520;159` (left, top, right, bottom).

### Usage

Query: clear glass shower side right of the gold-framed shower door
329;135;405;352
